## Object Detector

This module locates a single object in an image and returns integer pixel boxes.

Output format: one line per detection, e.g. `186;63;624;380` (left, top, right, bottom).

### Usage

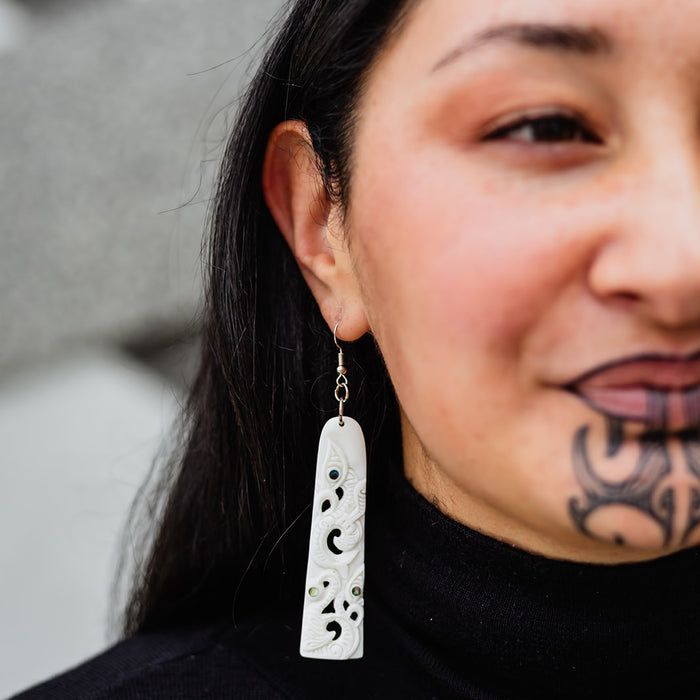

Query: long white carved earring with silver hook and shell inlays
299;324;367;659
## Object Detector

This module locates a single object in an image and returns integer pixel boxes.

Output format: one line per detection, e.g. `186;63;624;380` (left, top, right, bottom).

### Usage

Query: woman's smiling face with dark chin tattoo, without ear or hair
345;0;700;561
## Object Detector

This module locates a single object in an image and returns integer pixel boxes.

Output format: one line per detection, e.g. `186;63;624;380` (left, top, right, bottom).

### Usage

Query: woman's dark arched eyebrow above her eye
433;24;613;71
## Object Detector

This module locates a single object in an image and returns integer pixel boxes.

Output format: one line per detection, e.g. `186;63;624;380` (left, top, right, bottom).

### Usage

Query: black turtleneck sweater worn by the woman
17;462;700;700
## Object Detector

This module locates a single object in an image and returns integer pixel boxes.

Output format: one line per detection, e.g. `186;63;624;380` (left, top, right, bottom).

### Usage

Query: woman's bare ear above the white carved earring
262;121;369;341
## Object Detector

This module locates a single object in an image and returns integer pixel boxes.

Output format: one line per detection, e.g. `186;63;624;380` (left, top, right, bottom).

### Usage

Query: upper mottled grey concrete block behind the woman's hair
0;0;281;370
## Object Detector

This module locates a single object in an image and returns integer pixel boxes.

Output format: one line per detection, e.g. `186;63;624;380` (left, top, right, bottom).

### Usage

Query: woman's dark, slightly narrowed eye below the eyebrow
484;113;602;144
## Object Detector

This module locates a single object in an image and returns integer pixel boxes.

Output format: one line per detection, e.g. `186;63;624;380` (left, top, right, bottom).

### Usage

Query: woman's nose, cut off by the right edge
588;154;700;329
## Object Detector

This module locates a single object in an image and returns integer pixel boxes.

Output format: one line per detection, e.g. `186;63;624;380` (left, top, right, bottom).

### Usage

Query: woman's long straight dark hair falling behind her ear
124;0;411;634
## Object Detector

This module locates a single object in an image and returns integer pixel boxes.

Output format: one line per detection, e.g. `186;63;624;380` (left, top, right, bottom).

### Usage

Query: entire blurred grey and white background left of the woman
0;0;283;697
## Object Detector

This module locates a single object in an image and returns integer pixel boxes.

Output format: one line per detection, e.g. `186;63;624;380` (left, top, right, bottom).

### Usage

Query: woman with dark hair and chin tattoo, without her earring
15;0;700;698
